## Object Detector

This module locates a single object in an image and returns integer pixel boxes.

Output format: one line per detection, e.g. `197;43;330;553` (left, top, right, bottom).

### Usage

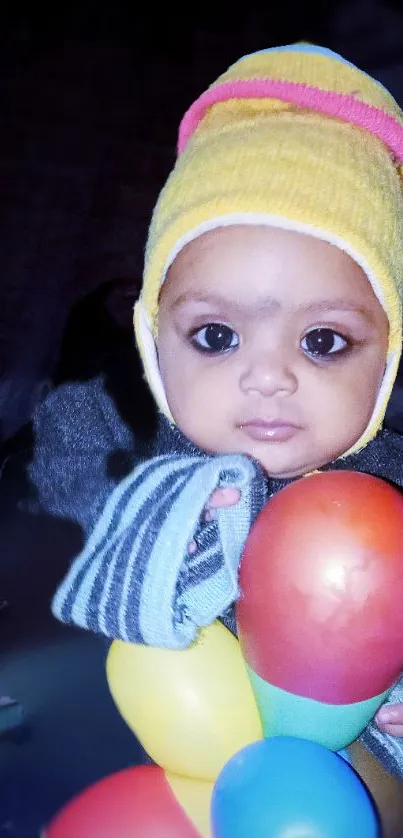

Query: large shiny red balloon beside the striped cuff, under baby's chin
237;471;403;704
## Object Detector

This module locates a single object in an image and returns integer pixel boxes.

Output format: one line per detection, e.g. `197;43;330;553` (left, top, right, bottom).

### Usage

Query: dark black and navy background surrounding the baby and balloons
0;0;403;838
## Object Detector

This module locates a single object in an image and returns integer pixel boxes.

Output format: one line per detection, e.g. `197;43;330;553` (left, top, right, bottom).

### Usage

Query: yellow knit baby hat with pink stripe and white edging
135;44;403;453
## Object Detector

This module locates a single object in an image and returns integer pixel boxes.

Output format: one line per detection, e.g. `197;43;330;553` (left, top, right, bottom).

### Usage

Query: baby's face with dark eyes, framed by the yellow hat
158;226;388;478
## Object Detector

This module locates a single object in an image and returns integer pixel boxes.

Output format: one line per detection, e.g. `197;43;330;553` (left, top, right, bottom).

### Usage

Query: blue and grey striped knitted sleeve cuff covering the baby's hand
52;423;267;649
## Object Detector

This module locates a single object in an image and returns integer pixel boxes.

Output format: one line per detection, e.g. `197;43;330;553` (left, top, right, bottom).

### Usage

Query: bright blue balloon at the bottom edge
211;736;380;838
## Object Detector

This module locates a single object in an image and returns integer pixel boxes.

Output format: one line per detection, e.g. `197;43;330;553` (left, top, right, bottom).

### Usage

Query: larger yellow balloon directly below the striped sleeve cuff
106;622;262;782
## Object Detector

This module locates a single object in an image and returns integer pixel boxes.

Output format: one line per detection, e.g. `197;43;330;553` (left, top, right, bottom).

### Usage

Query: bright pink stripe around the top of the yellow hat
178;79;403;165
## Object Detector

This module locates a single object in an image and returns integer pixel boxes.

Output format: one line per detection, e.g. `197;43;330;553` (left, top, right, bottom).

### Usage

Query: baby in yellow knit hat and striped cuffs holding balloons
53;45;403;835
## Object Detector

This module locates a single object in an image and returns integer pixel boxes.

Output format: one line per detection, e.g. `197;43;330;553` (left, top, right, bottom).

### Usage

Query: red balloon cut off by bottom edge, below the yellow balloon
43;765;199;838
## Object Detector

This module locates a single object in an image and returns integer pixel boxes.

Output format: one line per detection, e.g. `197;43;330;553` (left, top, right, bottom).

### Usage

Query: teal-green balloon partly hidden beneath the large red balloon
247;666;390;751
